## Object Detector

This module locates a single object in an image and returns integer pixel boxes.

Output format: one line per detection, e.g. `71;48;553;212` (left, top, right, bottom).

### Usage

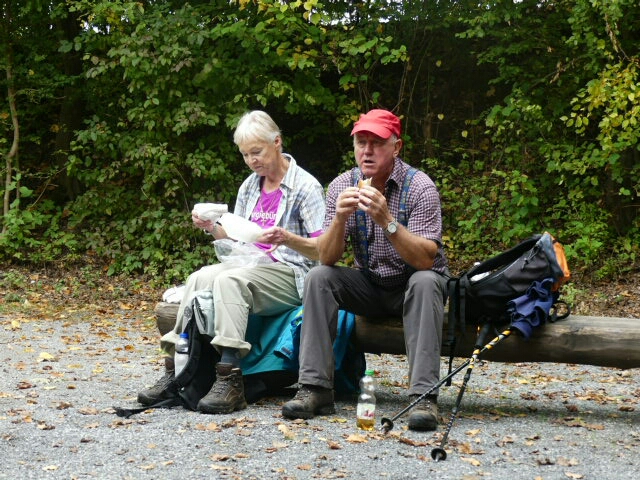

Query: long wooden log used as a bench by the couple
155;302;640;369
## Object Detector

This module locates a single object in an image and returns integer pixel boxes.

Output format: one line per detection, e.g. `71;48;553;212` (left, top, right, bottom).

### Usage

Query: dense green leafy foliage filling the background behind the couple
0;0;640;283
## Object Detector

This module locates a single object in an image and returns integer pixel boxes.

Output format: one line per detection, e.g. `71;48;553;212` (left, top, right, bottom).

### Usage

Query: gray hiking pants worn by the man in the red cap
298;265;447;395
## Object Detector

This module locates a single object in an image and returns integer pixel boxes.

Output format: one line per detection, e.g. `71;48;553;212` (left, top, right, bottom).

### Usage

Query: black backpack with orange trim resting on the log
445;232;570;376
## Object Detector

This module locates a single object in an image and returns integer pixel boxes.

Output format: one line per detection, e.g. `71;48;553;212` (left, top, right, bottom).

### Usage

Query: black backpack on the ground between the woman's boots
115;297;220;418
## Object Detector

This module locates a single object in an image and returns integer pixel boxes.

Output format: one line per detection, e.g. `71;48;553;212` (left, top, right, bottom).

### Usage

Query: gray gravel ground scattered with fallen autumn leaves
0;314;640;480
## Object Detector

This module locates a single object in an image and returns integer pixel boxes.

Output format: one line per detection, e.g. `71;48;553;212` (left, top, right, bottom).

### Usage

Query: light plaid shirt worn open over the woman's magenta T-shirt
233;153;325;298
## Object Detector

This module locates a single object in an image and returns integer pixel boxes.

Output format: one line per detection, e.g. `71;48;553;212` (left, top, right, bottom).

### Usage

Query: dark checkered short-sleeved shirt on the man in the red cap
324;158;447;287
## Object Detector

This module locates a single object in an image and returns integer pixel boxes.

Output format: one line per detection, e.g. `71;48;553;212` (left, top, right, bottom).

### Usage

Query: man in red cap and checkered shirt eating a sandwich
282;110;448;430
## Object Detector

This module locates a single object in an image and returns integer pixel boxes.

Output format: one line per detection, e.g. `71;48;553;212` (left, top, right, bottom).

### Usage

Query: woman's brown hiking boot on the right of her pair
198;363;247;413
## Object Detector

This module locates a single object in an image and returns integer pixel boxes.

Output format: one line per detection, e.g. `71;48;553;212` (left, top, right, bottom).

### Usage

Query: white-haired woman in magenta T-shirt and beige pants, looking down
138;111;325;413
